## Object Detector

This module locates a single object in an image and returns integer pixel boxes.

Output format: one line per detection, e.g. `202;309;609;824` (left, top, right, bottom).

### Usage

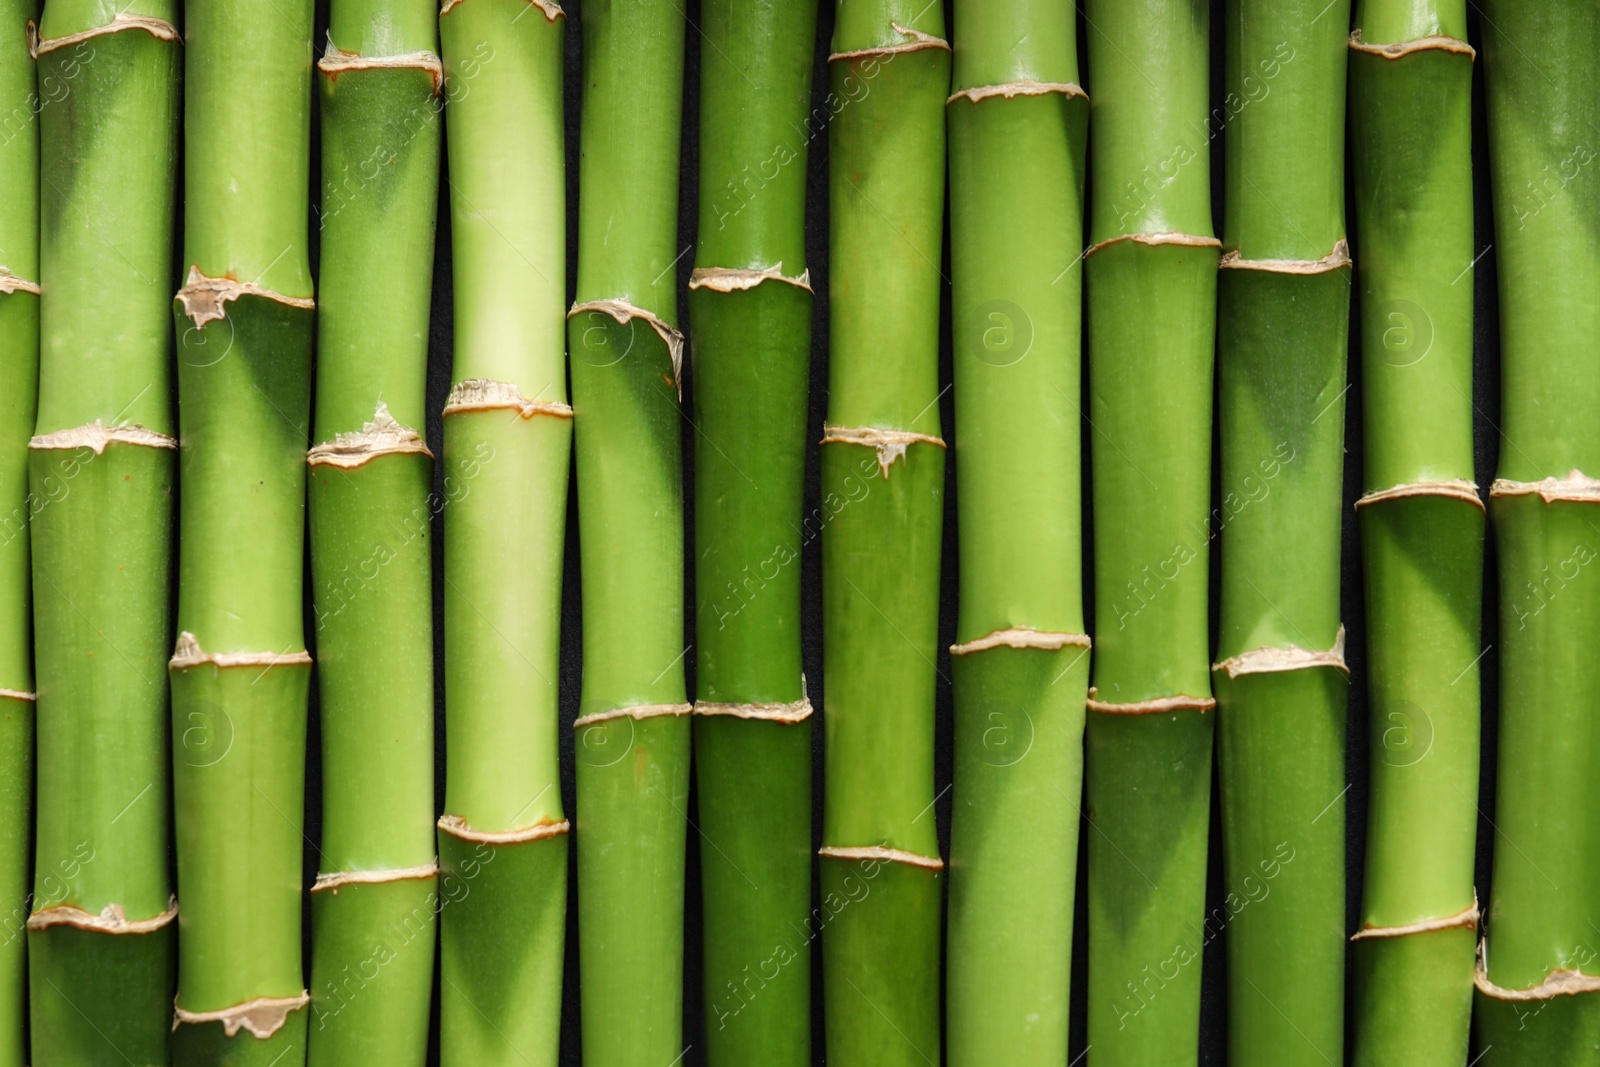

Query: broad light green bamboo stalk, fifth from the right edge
947;0;1090;1067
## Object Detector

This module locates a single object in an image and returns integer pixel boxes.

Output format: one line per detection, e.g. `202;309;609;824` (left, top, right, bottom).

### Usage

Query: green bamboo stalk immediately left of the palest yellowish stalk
307;0;443;1067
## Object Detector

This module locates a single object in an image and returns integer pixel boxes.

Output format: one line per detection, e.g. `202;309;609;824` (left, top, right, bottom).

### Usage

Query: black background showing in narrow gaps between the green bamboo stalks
284;0;1499;1067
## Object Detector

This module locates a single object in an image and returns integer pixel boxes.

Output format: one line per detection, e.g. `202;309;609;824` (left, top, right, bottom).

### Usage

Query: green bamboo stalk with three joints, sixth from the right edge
821;0;950;1067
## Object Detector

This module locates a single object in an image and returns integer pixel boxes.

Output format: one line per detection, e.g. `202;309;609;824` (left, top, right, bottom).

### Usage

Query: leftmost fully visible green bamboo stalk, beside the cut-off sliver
27;0;181;1067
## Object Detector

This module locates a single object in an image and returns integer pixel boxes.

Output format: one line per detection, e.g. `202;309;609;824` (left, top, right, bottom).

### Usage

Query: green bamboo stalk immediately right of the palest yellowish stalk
568;0;690;1067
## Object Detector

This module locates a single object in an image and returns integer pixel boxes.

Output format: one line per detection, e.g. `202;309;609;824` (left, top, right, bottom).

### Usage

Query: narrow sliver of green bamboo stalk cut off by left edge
0;0;35;1067
